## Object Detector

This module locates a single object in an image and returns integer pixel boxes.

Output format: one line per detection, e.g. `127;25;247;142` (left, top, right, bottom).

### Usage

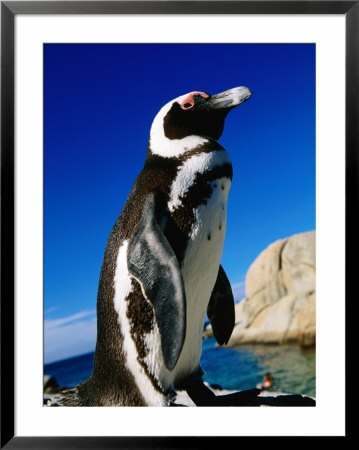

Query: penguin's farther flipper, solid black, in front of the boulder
207;266;235;345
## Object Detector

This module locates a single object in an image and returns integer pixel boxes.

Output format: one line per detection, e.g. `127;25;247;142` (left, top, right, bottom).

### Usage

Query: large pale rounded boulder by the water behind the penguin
226;231;316;347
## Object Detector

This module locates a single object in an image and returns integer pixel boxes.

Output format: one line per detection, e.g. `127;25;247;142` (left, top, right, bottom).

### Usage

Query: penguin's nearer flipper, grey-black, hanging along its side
127;193;186;370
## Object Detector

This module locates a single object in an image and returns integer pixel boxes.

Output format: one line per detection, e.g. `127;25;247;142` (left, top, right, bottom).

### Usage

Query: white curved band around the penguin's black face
150;91;209;158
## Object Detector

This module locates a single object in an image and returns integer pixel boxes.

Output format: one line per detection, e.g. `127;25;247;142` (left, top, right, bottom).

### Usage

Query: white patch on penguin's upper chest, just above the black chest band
168;150;231;212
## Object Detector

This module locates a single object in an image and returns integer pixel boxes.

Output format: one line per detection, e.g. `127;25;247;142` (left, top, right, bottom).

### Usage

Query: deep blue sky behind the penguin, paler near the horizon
44;44;315;362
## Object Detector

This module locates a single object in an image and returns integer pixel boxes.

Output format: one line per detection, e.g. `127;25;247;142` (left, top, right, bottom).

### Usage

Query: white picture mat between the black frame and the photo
15;15;345;436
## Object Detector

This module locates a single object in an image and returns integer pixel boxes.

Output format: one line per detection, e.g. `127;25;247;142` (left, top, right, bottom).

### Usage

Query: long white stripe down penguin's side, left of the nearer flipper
114;241;166;406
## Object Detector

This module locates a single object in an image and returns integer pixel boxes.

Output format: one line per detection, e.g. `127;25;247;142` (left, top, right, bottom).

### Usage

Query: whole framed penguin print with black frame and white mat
1;1;359;448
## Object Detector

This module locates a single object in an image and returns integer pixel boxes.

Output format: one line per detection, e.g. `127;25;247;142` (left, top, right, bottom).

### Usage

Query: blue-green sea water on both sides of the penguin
44;338;316;398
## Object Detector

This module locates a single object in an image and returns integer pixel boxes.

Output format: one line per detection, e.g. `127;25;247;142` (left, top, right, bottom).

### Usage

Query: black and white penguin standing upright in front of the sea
50;86;260;406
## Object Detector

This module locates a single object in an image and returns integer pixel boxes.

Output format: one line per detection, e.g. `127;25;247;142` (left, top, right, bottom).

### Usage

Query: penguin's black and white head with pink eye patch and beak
149;86;252;157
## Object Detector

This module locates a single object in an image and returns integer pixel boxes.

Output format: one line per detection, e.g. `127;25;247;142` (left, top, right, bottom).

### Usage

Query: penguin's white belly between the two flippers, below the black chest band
175;177;231;379
